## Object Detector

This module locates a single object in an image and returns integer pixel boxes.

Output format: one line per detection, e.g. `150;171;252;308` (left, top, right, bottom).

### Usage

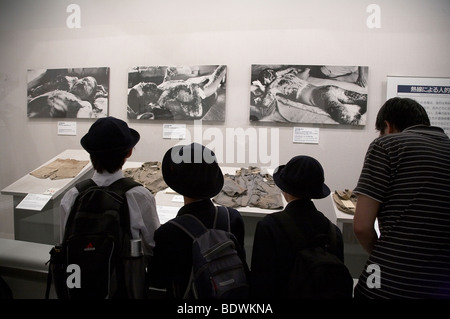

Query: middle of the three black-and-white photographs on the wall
127;65;227;121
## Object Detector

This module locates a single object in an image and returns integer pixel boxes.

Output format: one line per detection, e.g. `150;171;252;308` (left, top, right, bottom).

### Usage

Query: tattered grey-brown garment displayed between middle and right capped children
213;166;283;209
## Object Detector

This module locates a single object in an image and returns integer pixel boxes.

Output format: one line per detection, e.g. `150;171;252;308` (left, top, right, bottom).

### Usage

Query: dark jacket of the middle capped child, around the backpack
149;199;245;298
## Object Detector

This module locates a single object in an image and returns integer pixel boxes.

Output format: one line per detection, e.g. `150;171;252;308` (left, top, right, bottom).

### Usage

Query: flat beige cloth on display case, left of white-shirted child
30;158;89;180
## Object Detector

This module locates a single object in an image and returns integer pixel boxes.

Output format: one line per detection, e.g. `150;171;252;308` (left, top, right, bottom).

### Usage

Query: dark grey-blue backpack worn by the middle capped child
169;206;249;299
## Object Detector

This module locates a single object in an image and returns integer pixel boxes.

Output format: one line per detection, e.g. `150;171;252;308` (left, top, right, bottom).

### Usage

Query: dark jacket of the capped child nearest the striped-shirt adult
251;199;344;299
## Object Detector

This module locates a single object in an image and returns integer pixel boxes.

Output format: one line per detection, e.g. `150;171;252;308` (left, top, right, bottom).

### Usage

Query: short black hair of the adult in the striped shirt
375;97;430;133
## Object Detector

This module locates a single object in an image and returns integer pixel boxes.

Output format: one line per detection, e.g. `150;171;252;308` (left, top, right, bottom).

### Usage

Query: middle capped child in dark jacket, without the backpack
150;143;247;299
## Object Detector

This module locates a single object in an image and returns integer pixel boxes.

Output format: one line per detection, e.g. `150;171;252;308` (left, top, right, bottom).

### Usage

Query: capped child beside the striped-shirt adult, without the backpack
251;156;344;299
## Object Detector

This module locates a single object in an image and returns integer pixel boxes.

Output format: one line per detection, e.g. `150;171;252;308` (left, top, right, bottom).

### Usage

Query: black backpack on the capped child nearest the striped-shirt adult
272;213;353;299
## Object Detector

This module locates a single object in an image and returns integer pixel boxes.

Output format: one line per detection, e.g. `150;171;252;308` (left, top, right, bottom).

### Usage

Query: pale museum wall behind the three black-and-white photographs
0;0;450;218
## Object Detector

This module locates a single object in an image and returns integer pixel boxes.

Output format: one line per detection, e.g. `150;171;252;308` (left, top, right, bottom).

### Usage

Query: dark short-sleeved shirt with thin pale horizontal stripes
354;125;450;298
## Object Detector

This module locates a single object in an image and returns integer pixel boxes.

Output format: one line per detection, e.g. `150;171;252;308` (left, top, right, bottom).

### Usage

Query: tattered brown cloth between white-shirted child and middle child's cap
123;162;168;194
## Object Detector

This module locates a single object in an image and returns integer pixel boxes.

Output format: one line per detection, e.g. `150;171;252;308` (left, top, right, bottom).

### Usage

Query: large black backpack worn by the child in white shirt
46;178;145;299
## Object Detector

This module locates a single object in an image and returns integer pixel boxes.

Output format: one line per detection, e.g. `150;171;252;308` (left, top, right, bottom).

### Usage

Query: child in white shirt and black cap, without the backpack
60;116;160;255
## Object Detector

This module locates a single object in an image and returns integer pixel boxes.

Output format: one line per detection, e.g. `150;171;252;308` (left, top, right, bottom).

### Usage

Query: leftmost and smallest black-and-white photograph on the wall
27;67;109;119
